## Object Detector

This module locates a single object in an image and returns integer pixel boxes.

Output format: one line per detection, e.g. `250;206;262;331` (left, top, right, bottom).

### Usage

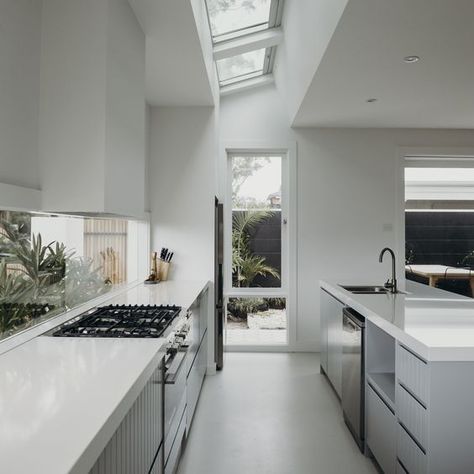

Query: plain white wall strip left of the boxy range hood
0;0;42;193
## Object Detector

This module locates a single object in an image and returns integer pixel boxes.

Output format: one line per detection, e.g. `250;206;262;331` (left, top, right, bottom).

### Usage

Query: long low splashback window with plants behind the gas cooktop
0;211;148;340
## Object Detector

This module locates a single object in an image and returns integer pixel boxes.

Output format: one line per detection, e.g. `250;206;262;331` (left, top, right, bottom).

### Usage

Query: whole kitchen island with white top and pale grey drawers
320;281;474;474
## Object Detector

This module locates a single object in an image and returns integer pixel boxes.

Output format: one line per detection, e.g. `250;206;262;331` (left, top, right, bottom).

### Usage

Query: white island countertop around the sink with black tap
320;281;474;361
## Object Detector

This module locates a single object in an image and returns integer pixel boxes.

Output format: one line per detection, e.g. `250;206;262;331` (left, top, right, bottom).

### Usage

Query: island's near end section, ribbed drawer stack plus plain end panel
395;343;474;474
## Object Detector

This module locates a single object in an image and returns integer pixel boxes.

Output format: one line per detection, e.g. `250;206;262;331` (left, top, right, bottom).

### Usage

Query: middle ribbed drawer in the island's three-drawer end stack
395;384;428;449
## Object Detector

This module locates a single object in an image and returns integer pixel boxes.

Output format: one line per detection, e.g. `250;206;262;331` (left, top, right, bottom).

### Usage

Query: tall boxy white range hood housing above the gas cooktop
39;0;145;218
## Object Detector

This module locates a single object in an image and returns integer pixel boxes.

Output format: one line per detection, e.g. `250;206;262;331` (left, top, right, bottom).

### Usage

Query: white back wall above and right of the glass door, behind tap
220;87;474;350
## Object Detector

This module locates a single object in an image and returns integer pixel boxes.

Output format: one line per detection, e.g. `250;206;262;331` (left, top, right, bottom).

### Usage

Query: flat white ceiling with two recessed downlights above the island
293;0;474;128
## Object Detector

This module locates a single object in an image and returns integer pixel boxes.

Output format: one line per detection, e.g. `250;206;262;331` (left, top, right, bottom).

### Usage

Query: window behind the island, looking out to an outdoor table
405;157;474;297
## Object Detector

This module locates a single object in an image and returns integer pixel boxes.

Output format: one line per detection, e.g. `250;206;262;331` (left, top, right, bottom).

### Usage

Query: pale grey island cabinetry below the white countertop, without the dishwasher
321;289;474;474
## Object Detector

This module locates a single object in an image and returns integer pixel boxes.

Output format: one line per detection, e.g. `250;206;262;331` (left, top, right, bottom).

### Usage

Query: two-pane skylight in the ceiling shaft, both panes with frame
206;0;283;88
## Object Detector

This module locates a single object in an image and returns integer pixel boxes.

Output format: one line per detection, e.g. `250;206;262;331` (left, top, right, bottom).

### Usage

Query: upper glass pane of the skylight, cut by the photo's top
207;0;271;41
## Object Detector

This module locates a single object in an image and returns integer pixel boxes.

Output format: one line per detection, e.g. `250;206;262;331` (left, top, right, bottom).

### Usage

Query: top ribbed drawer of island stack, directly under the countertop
396;344;429;406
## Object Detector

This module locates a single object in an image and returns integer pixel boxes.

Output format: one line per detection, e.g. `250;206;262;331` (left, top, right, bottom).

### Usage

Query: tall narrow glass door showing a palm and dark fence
225;154;288;347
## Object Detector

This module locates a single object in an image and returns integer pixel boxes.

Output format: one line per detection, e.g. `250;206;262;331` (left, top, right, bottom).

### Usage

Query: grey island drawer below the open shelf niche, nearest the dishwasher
367;385;398;474
